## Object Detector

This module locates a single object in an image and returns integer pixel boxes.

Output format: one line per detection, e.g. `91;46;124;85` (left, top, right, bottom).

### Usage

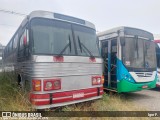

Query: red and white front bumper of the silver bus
30;87;103;109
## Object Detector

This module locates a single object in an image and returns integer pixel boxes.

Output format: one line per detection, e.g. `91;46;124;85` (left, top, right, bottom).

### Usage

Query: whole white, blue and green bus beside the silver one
98;27;157;93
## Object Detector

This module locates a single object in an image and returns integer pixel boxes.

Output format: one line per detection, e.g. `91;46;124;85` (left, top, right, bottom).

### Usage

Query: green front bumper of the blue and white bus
117;79;157;93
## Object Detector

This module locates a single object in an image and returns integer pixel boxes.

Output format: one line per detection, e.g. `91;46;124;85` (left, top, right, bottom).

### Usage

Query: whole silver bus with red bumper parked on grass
3;11;103;109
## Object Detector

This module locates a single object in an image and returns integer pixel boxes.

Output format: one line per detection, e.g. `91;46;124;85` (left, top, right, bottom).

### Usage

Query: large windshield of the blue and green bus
122;37;156;71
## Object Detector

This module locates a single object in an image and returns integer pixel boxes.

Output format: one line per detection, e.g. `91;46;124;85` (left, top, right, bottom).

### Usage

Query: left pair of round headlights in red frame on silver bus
44;79;61;91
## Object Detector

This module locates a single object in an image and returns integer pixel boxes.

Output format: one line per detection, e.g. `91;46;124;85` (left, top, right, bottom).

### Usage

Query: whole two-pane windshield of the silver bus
31;18;99;56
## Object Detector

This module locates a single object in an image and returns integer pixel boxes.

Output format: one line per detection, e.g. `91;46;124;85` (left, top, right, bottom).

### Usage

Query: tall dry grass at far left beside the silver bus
0;73;32;111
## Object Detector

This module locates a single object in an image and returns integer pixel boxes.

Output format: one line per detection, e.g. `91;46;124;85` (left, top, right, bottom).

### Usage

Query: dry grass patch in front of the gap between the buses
62;93;146;111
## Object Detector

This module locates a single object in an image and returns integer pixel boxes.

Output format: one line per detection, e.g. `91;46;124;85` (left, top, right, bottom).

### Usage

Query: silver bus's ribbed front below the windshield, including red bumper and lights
30;56;103;109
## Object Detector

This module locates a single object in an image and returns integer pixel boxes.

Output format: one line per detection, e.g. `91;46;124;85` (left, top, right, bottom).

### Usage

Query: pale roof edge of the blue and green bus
97;26;153;40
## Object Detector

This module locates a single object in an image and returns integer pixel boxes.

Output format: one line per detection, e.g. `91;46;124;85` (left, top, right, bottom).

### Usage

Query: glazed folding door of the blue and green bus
102;38;117;89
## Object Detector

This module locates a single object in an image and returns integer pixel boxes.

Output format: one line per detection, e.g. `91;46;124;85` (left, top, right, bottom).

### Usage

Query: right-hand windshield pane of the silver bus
73;25;99;57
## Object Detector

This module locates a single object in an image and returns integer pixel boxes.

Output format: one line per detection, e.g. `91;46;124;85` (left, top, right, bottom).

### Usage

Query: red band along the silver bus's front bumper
30;87;103;105
